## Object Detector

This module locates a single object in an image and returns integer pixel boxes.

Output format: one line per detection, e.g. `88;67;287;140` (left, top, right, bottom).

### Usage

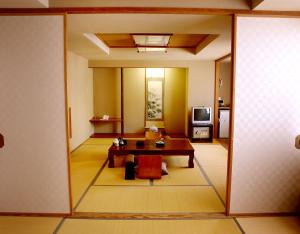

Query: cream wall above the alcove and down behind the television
89;60;215;120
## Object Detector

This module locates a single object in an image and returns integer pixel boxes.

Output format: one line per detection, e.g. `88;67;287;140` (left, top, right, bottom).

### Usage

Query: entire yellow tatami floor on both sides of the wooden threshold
0;138;300;234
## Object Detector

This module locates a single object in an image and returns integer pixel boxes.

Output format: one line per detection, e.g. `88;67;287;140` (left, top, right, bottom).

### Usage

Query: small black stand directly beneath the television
190;124;213;142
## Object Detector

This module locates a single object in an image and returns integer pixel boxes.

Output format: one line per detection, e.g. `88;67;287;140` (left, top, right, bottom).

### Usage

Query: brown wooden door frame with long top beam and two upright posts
0;7;300;216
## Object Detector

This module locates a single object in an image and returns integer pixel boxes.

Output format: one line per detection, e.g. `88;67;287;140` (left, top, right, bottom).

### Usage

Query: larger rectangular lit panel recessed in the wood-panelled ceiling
132;35;170;47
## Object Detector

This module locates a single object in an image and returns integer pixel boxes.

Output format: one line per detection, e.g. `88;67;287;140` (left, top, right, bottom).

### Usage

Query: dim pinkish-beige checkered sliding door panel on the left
0;15;70;213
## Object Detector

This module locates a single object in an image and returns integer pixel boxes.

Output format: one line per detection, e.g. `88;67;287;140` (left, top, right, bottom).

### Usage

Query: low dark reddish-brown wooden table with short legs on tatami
108;139;194;168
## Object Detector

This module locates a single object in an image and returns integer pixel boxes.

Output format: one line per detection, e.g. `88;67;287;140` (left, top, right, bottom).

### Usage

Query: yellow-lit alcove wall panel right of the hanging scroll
164;68;187;133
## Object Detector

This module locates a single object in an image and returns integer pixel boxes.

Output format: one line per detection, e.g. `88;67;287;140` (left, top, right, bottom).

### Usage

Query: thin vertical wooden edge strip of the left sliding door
64;14;73;214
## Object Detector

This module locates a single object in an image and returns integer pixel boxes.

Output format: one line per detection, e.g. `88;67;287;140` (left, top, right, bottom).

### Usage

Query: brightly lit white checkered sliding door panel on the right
230;17;300;213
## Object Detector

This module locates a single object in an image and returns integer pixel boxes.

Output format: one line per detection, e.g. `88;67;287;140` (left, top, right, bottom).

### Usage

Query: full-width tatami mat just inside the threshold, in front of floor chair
76;186;224;213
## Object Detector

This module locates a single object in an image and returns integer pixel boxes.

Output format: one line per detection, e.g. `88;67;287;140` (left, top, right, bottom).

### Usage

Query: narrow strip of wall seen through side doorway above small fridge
219;62;231;105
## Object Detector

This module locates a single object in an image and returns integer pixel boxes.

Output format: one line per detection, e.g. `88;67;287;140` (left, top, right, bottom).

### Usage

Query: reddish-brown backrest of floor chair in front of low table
136;155;162;179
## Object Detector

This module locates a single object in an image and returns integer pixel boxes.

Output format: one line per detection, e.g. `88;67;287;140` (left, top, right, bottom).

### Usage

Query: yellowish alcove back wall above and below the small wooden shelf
93;68;121;133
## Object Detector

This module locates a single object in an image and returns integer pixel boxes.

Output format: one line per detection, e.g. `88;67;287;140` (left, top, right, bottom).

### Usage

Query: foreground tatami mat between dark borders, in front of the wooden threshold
59;219;240;234
